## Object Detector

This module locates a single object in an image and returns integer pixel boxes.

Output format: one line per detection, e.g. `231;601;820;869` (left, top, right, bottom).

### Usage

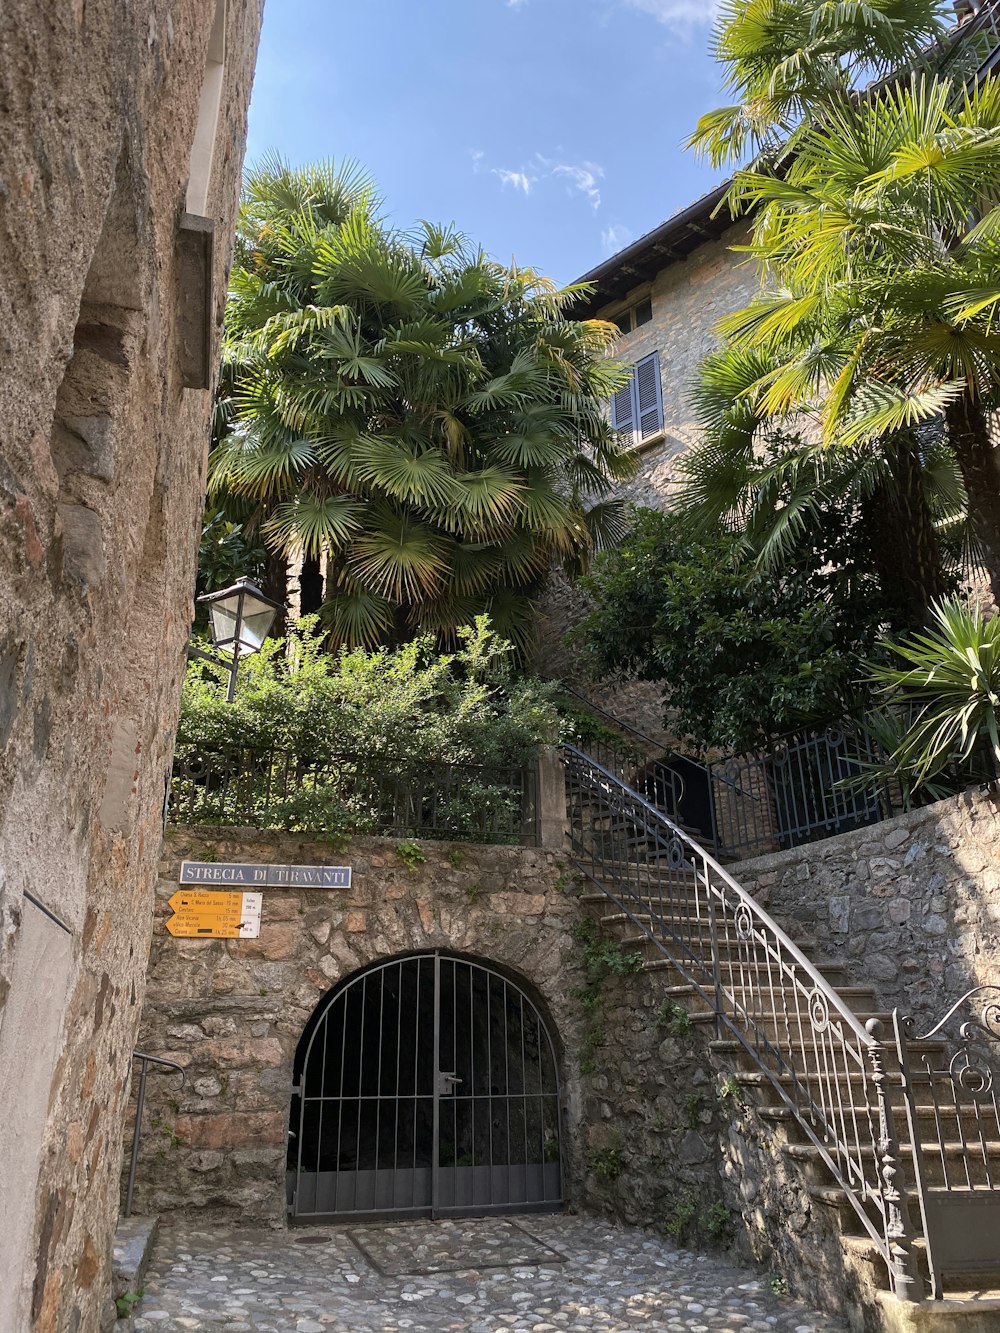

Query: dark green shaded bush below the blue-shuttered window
573;509;901;750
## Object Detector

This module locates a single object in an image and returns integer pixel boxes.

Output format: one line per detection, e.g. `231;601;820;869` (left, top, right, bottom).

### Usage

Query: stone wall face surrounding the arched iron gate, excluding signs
127;828;584;1225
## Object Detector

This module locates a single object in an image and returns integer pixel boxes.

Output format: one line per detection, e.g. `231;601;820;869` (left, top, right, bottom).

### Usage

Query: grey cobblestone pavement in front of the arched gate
135;1216;847;1333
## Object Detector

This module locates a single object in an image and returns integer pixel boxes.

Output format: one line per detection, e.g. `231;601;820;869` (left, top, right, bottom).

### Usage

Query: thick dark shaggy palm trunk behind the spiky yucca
864;436;948;631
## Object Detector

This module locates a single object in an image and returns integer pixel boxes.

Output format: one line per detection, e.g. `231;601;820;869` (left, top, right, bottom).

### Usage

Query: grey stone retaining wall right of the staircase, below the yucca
729;792;1000;1018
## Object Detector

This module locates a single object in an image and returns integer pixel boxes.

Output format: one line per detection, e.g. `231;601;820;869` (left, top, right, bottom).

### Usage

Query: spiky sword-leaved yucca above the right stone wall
869;601;1000;786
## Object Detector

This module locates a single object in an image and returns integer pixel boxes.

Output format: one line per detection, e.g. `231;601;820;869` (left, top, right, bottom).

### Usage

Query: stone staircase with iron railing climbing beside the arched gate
567;748;1000;1333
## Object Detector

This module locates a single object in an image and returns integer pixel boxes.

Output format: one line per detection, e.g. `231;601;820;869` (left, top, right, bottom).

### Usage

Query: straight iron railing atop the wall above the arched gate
168;746;536;842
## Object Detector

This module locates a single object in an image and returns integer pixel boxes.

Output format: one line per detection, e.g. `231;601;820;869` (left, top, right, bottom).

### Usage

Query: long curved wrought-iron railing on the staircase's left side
563;745;923;1300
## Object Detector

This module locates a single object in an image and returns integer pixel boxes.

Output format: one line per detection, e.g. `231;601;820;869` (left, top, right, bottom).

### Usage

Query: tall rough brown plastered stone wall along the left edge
0;0;261;1333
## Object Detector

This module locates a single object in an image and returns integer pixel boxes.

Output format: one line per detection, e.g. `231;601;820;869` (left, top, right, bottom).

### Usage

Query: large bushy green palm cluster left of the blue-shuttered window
209;161;633;648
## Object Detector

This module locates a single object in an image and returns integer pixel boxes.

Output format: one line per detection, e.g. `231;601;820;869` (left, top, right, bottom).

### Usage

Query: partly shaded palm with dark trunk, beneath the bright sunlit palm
680;343;975;628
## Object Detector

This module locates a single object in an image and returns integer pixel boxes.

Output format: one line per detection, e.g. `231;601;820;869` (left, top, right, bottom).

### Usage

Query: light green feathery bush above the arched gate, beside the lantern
172;617;557;841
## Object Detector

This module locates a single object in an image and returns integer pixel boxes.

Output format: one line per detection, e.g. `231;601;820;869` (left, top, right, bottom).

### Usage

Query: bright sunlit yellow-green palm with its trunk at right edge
720;76;1000;597
